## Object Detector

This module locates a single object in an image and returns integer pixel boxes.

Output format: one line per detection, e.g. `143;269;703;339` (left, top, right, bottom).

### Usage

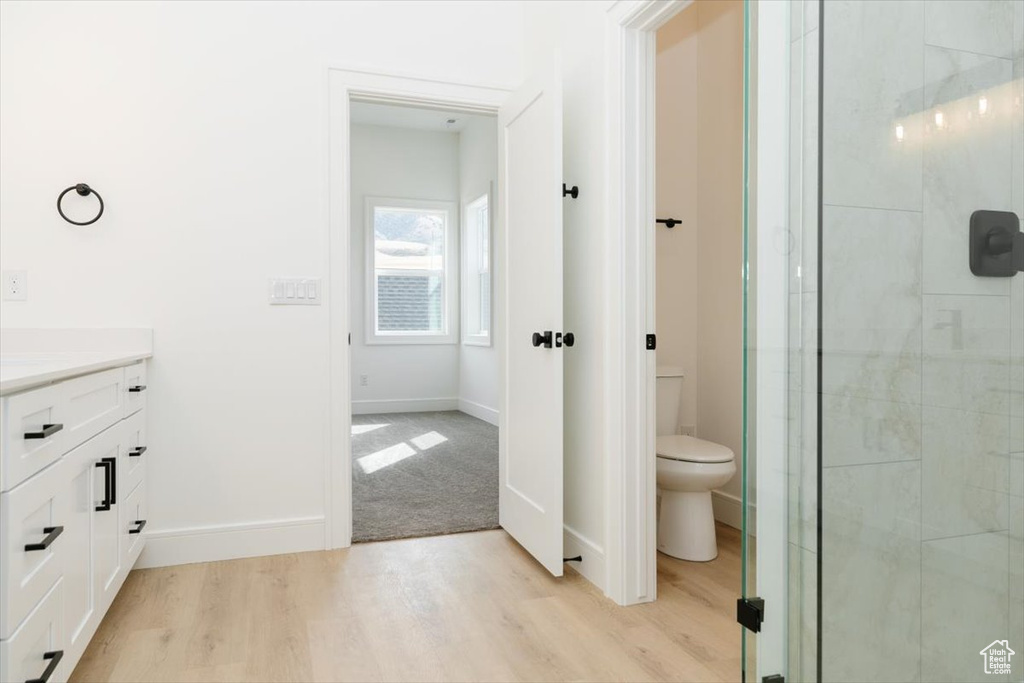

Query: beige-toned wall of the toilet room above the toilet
656;0;743;525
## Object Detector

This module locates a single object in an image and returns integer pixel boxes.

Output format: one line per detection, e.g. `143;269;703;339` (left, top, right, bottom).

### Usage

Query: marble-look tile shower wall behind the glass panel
815;0;1024;681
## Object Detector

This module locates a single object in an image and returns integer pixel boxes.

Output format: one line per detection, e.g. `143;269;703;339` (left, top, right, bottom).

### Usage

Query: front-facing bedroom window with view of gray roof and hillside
367;199;457;344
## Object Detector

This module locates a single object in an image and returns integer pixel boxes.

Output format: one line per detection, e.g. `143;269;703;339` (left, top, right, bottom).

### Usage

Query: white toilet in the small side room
656;368;736;562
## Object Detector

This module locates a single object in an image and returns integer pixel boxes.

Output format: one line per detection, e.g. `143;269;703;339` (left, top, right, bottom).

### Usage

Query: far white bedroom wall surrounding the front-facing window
349;125;460;413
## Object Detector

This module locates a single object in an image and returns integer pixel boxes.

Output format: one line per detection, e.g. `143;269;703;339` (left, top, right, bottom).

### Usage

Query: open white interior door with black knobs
498;70;565;577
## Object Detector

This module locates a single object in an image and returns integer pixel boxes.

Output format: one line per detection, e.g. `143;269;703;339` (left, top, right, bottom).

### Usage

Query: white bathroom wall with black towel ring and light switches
0;2;523;561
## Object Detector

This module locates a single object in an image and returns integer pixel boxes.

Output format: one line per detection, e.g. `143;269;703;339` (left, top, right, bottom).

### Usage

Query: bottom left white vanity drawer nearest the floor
0;581;68;683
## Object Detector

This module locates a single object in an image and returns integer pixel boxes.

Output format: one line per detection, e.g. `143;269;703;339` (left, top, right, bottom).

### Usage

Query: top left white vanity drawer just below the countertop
0;384;69;490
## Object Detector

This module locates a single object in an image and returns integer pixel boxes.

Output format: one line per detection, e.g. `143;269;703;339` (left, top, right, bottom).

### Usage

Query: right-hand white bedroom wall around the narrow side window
459;118;502;424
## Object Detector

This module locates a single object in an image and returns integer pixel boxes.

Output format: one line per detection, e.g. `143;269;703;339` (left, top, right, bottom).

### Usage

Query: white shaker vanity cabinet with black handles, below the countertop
0;360;152;681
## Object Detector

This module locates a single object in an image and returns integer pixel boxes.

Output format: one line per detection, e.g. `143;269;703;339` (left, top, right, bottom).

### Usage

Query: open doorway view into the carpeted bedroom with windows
349;101;500;543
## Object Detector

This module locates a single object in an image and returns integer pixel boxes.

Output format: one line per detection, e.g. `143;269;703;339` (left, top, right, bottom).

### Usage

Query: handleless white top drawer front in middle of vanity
58;368;125;452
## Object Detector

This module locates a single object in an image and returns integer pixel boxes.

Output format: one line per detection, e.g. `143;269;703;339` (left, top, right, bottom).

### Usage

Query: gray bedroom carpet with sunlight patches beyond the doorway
352;412;498;543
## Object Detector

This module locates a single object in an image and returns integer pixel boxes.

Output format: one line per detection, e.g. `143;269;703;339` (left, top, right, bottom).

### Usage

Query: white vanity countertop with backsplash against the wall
0;329;153;395
